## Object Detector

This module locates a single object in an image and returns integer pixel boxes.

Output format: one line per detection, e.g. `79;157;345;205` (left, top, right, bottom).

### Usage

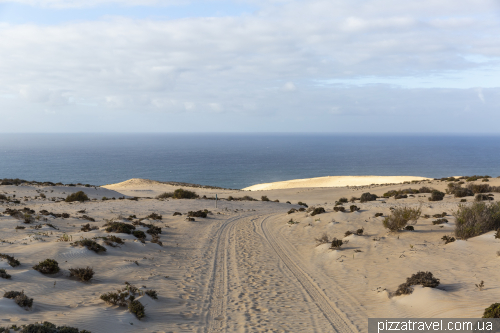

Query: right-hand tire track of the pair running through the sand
256;215;358;333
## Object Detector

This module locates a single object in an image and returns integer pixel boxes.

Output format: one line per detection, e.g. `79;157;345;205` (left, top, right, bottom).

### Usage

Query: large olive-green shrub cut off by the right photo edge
453;202;500;239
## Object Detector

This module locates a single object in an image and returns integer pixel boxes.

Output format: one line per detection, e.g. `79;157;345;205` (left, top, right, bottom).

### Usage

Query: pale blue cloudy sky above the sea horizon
0;0;500;134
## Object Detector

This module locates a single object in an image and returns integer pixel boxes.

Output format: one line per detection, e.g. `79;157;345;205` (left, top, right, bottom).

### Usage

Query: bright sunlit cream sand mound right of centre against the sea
243;176;431;191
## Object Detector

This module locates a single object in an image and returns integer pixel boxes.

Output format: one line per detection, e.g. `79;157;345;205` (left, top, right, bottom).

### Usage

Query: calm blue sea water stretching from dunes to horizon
0;133;500;188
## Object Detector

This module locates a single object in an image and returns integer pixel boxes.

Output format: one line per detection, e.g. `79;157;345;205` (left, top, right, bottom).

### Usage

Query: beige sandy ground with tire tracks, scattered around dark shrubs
0;175;500;333
